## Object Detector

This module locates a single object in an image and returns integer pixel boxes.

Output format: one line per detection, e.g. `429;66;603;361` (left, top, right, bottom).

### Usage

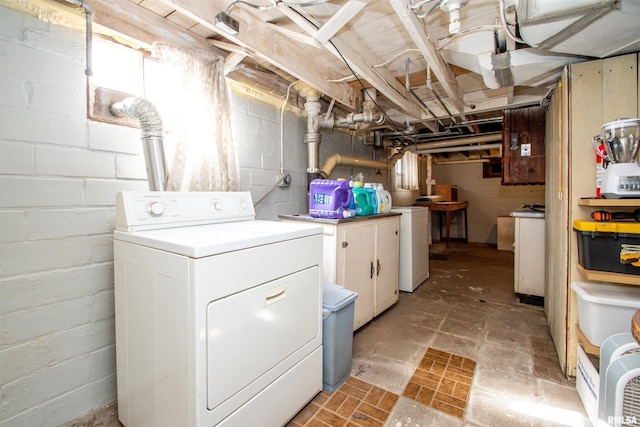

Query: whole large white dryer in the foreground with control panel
114;192;322;427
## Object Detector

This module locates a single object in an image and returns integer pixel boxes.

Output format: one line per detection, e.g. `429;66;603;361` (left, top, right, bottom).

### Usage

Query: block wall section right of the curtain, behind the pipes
231;94;387;219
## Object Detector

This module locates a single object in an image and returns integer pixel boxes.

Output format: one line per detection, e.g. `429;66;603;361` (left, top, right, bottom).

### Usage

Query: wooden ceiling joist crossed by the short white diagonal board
282;7;426;125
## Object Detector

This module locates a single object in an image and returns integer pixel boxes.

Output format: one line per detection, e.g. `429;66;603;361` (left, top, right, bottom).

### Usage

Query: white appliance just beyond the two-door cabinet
391;206;430;292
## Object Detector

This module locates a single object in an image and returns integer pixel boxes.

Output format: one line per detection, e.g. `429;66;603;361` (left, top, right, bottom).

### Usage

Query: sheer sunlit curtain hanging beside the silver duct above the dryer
152;43;240;191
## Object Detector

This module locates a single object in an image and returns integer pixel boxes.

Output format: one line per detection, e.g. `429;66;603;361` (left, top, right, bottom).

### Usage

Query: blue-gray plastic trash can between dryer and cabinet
322;284;358;391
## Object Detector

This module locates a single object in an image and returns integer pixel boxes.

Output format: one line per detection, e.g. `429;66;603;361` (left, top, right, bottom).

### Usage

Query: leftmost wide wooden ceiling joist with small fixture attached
149;0;360;111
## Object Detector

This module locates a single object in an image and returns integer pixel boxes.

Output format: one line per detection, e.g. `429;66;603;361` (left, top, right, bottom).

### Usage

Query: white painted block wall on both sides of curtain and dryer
0;7;382;427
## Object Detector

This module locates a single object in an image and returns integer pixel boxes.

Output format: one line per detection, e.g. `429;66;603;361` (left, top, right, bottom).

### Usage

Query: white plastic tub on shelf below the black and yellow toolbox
571;282;640;347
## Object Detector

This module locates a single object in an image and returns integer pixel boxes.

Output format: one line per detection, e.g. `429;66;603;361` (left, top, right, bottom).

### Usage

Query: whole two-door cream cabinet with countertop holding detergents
280;213;400;331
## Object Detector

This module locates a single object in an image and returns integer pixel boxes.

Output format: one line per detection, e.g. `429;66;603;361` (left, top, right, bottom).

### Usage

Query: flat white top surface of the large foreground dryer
113;220;322;258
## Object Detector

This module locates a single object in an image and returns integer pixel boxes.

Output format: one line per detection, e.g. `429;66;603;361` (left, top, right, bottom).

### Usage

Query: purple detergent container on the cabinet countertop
309;179;353;219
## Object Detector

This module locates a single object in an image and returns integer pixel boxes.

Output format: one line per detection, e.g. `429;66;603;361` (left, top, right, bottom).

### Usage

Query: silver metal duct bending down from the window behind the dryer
111;97;167;191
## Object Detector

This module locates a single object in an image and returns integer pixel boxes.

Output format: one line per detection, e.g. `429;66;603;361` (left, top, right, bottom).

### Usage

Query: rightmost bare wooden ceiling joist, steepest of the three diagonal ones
389;0;464;114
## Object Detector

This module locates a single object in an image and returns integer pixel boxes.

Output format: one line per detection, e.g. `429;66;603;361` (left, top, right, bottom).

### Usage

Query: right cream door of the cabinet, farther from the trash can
374;217;400;316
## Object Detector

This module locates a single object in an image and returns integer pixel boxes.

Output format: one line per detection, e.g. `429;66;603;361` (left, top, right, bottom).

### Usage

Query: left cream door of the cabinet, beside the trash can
336;222;376;331
